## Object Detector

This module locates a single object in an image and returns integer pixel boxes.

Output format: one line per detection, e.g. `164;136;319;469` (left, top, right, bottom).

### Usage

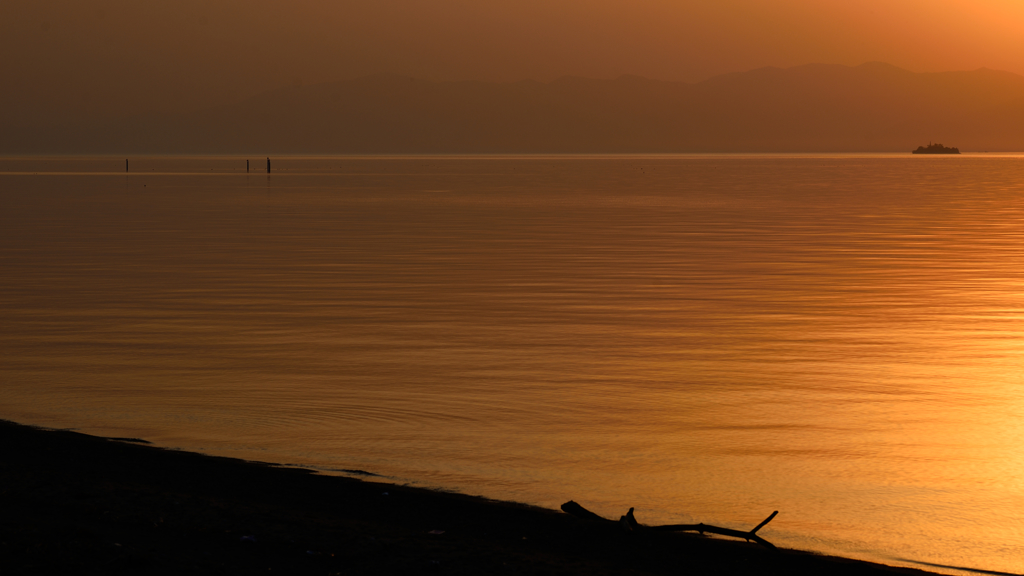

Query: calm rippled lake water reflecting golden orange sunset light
0;155;1024;572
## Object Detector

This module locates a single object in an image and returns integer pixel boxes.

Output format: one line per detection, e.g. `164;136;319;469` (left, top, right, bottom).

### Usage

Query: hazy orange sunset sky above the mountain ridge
0;0;1024;122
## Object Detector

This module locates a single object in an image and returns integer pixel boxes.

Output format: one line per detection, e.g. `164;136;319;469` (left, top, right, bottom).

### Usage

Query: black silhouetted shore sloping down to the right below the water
0;420;930;576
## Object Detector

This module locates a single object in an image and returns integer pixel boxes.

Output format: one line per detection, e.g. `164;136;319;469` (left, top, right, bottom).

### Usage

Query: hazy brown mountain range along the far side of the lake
6;63;1024;155
